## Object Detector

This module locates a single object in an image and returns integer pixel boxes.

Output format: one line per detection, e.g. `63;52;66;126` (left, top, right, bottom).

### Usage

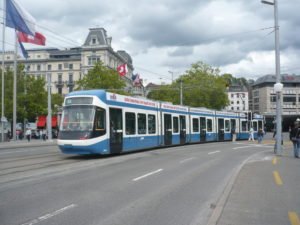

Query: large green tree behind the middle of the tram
148;62;228;110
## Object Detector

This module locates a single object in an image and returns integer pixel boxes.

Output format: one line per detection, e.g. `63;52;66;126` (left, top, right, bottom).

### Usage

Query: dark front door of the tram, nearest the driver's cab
109;108;123;154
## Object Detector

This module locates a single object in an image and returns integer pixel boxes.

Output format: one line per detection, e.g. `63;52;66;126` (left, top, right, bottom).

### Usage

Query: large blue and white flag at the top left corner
5;0;35;36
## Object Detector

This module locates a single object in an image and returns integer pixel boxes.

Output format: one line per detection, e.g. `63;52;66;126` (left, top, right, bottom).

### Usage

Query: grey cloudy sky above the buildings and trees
1;0;300;83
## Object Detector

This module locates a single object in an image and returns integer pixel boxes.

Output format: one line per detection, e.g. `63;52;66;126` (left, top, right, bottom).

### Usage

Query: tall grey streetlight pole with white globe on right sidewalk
261;0;283;156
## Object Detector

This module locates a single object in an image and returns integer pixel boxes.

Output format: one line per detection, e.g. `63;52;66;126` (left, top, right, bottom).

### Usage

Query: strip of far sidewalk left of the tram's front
0;139;57;150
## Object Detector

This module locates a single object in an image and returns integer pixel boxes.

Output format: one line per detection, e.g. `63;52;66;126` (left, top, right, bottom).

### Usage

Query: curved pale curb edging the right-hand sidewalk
207;152;268;225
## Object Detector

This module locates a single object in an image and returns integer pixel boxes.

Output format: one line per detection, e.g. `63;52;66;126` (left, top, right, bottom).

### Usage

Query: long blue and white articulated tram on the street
57;90;264;154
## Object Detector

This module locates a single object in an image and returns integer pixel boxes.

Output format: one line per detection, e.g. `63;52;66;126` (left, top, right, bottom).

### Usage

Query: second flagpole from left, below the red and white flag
12;30;18;140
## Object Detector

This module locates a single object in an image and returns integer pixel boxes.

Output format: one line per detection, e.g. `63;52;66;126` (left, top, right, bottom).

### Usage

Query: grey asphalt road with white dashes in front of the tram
0;142;272;225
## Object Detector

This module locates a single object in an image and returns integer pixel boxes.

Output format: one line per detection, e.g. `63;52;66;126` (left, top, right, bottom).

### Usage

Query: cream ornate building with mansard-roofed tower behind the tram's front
1;28;143;96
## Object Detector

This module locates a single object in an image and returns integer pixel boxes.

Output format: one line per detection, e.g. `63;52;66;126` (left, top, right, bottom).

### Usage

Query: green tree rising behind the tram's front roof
76;62;126;94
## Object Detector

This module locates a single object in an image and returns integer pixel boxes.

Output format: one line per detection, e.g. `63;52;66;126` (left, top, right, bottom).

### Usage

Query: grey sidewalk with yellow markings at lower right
209;142;300;225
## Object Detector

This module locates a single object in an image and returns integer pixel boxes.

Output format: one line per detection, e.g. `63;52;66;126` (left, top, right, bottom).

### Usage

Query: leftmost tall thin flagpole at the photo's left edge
1;0;6;142
